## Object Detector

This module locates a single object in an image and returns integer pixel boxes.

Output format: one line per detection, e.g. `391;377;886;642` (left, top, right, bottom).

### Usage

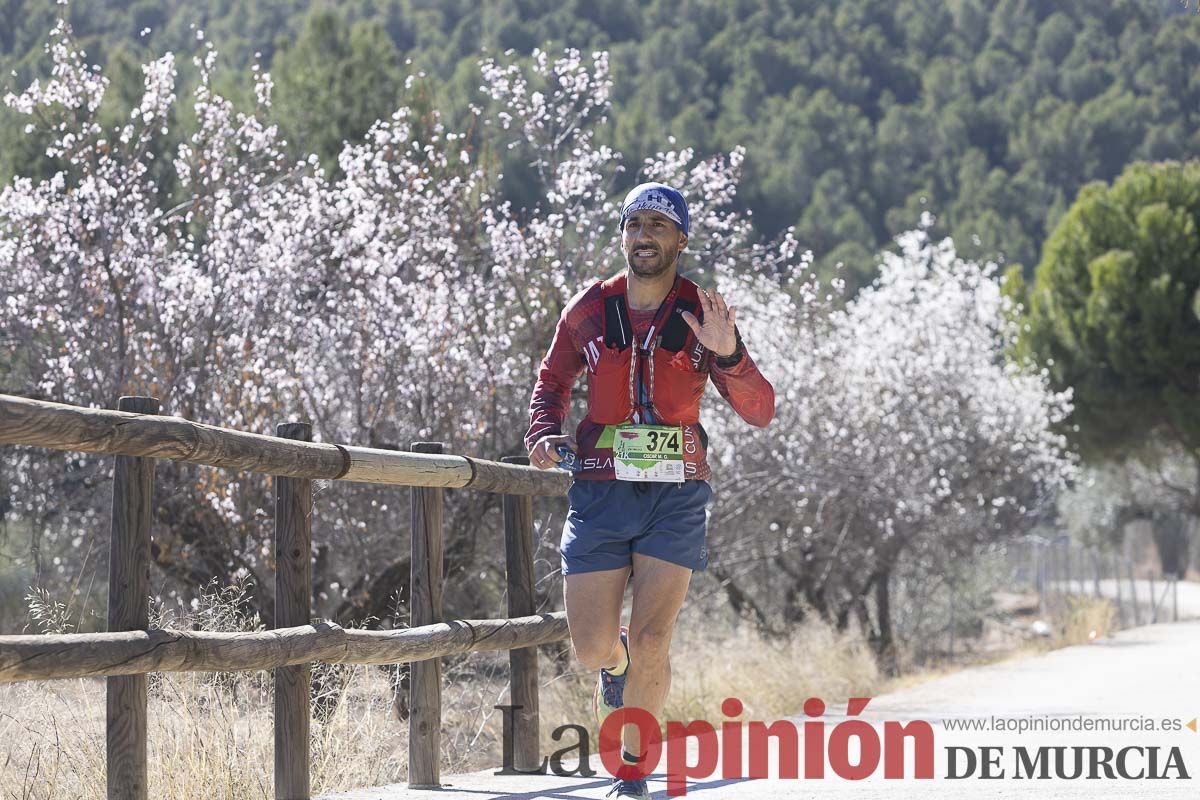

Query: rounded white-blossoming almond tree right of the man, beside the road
713;220;1075;671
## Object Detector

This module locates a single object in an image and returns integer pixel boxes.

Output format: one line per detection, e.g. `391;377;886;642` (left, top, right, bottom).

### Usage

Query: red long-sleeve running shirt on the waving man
524;282;775;480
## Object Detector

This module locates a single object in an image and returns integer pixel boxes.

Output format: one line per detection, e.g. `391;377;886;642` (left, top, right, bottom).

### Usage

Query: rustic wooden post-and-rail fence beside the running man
0;395;570;800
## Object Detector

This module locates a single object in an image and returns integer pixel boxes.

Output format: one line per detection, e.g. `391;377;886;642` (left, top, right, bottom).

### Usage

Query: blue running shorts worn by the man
559;480;713;575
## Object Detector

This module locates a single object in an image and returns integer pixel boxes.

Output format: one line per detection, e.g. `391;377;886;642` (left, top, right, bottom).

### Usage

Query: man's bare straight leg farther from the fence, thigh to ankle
623;553;691;756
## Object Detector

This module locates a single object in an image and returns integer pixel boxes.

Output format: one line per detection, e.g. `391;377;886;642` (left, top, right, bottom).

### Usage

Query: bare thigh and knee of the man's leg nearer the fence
563;566;637;669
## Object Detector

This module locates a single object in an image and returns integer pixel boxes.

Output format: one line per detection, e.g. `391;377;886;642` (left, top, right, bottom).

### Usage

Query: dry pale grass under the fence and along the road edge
0;614;878;800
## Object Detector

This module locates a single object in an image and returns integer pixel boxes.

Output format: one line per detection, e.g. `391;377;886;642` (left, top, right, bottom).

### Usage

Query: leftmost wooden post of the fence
106;397;158;800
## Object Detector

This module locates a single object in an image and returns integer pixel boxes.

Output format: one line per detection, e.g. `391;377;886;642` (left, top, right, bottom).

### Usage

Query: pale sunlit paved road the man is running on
330;621;1200;800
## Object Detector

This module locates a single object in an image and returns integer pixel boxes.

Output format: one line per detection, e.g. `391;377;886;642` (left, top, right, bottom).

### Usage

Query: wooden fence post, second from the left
272;422;312;800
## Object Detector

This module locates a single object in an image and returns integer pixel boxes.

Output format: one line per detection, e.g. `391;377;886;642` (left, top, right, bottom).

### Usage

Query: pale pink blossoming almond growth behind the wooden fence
0;25;806;613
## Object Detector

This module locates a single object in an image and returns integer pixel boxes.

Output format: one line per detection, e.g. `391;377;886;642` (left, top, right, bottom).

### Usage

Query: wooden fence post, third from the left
408;441;444;789
